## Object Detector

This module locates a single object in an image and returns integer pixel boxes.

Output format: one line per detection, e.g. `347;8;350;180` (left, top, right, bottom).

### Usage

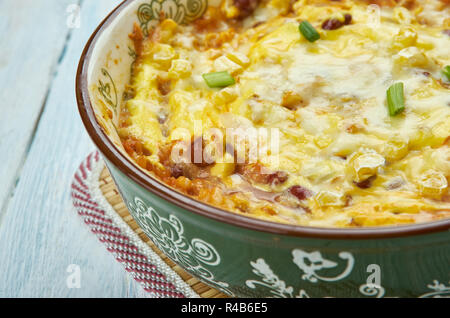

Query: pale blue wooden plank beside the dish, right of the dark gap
0;0;148;297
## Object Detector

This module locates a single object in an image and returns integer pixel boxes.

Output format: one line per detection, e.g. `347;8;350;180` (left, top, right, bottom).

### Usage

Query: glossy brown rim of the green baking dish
76;0;450;239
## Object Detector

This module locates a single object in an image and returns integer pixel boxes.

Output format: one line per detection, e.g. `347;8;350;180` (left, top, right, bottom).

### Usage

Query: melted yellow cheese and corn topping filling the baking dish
119;0;450;227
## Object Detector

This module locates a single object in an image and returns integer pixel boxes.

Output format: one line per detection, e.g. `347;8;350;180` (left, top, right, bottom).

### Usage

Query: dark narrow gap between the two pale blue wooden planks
0;0;84;226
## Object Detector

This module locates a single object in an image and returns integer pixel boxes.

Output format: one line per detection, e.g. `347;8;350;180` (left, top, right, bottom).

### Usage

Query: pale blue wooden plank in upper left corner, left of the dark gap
0;0;74;217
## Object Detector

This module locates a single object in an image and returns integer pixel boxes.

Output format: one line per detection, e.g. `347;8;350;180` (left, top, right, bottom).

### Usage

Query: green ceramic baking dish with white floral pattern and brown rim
77;0;450;297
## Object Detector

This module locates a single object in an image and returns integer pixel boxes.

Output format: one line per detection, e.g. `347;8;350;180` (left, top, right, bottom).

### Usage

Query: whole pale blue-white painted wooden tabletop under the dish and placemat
0;0;146;297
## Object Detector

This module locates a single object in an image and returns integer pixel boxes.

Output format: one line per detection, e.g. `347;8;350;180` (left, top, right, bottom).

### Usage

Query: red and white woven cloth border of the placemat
71;152;199;298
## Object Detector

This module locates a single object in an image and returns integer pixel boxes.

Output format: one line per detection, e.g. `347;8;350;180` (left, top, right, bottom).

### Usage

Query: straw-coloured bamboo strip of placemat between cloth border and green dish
99;168;228;298
